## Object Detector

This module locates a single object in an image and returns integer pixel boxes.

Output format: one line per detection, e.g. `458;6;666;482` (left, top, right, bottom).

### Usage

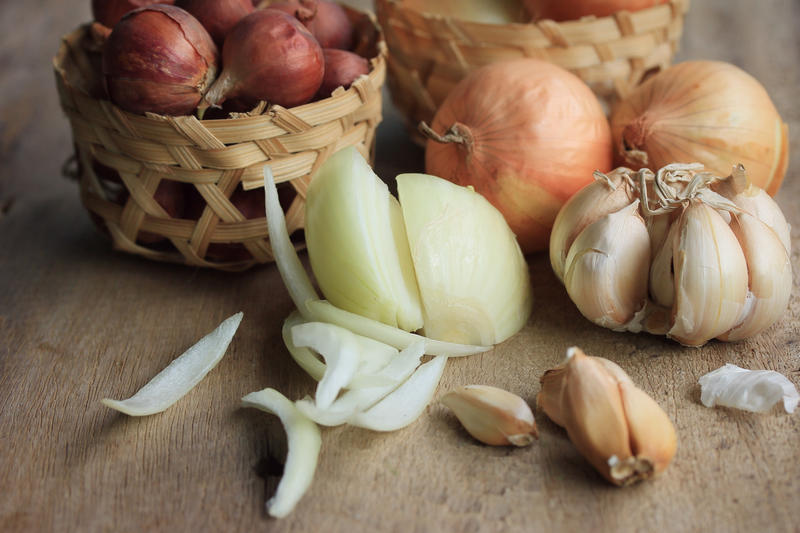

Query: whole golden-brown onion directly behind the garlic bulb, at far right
611;61;789;196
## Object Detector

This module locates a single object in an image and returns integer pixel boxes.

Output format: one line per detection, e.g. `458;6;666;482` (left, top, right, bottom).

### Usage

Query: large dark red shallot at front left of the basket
103;5;218;115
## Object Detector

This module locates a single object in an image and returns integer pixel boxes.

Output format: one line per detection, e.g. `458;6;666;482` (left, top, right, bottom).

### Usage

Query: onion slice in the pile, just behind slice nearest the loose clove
295;341;432;426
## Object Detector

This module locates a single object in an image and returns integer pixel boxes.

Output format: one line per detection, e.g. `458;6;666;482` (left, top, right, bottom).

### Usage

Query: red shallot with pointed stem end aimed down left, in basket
206;9;325;107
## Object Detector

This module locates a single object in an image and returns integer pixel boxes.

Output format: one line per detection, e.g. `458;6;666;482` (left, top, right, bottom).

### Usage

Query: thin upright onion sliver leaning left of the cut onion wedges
264;165;319;318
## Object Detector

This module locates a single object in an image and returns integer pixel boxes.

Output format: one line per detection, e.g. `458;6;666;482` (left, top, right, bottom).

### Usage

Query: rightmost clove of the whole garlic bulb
719;213;792;341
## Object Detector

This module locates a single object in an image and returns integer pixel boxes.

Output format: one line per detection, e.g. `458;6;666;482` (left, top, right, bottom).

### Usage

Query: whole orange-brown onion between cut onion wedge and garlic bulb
425;58;611;253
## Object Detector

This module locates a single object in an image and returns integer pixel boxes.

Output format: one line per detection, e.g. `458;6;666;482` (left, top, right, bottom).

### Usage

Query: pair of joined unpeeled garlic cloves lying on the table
537;347;677;486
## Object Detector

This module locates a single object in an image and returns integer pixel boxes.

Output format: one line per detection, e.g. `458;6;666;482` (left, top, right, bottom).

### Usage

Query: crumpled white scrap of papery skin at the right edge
700;363;800;413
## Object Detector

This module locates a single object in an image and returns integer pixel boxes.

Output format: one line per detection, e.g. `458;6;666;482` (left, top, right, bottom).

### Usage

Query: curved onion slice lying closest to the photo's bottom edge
242;389;322;518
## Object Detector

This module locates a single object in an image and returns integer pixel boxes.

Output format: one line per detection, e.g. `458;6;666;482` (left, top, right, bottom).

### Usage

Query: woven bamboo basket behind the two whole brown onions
375;0;689;143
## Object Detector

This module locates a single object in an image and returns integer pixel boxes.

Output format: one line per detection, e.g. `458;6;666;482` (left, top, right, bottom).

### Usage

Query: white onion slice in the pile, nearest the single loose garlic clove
347;356;447;431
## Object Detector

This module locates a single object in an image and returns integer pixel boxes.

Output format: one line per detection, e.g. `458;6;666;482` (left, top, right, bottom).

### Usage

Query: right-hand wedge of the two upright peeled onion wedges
397;174;533;345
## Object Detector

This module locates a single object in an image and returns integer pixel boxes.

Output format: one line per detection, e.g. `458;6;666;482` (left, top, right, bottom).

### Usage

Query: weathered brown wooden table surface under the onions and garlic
0;0;800;532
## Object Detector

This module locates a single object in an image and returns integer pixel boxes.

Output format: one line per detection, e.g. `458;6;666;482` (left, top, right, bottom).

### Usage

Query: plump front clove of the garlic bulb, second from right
667;200;747;346
